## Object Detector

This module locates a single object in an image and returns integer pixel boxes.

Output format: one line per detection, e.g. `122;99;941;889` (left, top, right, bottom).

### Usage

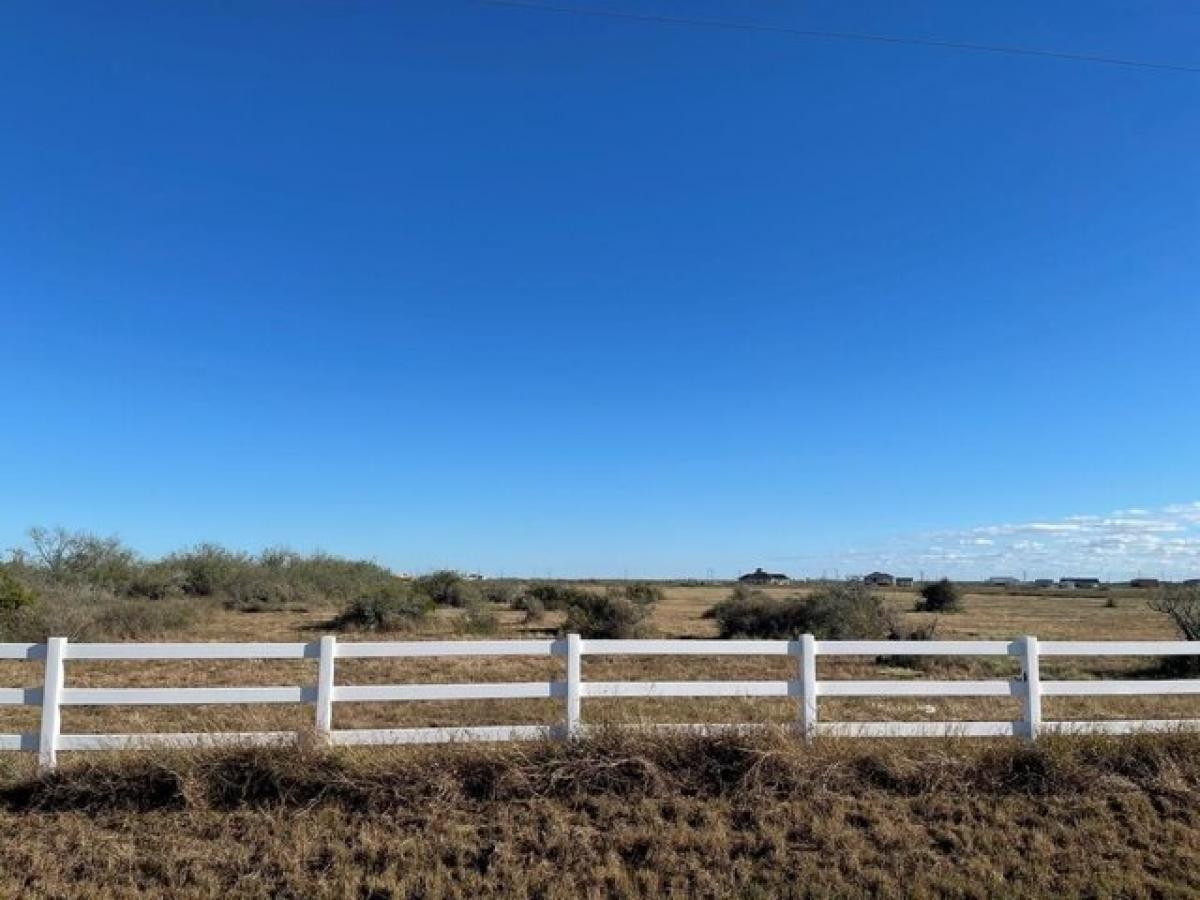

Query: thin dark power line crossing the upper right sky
480;0;1200;74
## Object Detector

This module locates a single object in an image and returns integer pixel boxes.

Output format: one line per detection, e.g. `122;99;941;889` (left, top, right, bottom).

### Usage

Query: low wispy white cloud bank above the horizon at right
792;502;1200;580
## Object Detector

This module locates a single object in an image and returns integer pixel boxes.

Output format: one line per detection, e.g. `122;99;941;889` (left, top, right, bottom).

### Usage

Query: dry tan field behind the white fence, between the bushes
0;586;1200;769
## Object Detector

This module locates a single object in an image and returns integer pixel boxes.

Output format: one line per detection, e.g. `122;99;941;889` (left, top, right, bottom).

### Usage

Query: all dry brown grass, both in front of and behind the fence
0;587;1200;898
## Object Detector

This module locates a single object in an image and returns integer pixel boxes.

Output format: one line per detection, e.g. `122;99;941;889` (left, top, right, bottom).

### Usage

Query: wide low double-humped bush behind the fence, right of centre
706;584;895;641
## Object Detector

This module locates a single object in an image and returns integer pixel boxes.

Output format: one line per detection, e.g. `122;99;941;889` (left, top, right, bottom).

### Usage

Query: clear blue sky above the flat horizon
0;0;1200;577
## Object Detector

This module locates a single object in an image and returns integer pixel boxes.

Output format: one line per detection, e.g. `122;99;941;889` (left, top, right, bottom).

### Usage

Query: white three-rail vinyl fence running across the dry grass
7;635;1200;769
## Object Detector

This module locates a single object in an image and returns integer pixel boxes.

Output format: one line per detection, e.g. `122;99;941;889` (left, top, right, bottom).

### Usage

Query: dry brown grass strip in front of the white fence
0;733;1200;898
